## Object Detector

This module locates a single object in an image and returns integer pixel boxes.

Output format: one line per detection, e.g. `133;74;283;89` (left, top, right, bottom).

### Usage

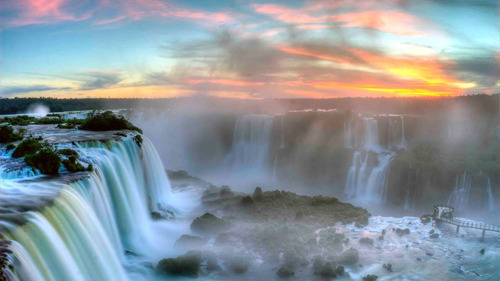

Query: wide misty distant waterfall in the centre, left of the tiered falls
229;115;274;176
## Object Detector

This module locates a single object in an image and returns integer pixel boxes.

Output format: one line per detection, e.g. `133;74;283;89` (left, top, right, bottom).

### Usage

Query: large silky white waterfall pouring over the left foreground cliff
0;137;181;281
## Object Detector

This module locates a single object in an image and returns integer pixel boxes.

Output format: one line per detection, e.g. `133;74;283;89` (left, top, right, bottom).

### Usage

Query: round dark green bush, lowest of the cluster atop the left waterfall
24;145;61;175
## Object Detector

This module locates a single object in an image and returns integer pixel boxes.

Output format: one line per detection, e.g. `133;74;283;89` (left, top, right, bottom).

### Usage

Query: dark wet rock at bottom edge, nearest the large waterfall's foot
156;251;201;277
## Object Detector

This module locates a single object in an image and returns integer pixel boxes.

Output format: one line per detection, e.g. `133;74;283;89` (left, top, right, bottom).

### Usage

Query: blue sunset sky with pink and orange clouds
0;0;500;99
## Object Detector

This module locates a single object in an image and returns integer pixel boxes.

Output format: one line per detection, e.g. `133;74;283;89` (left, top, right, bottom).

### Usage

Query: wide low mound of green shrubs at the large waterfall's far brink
80;111;142;134
